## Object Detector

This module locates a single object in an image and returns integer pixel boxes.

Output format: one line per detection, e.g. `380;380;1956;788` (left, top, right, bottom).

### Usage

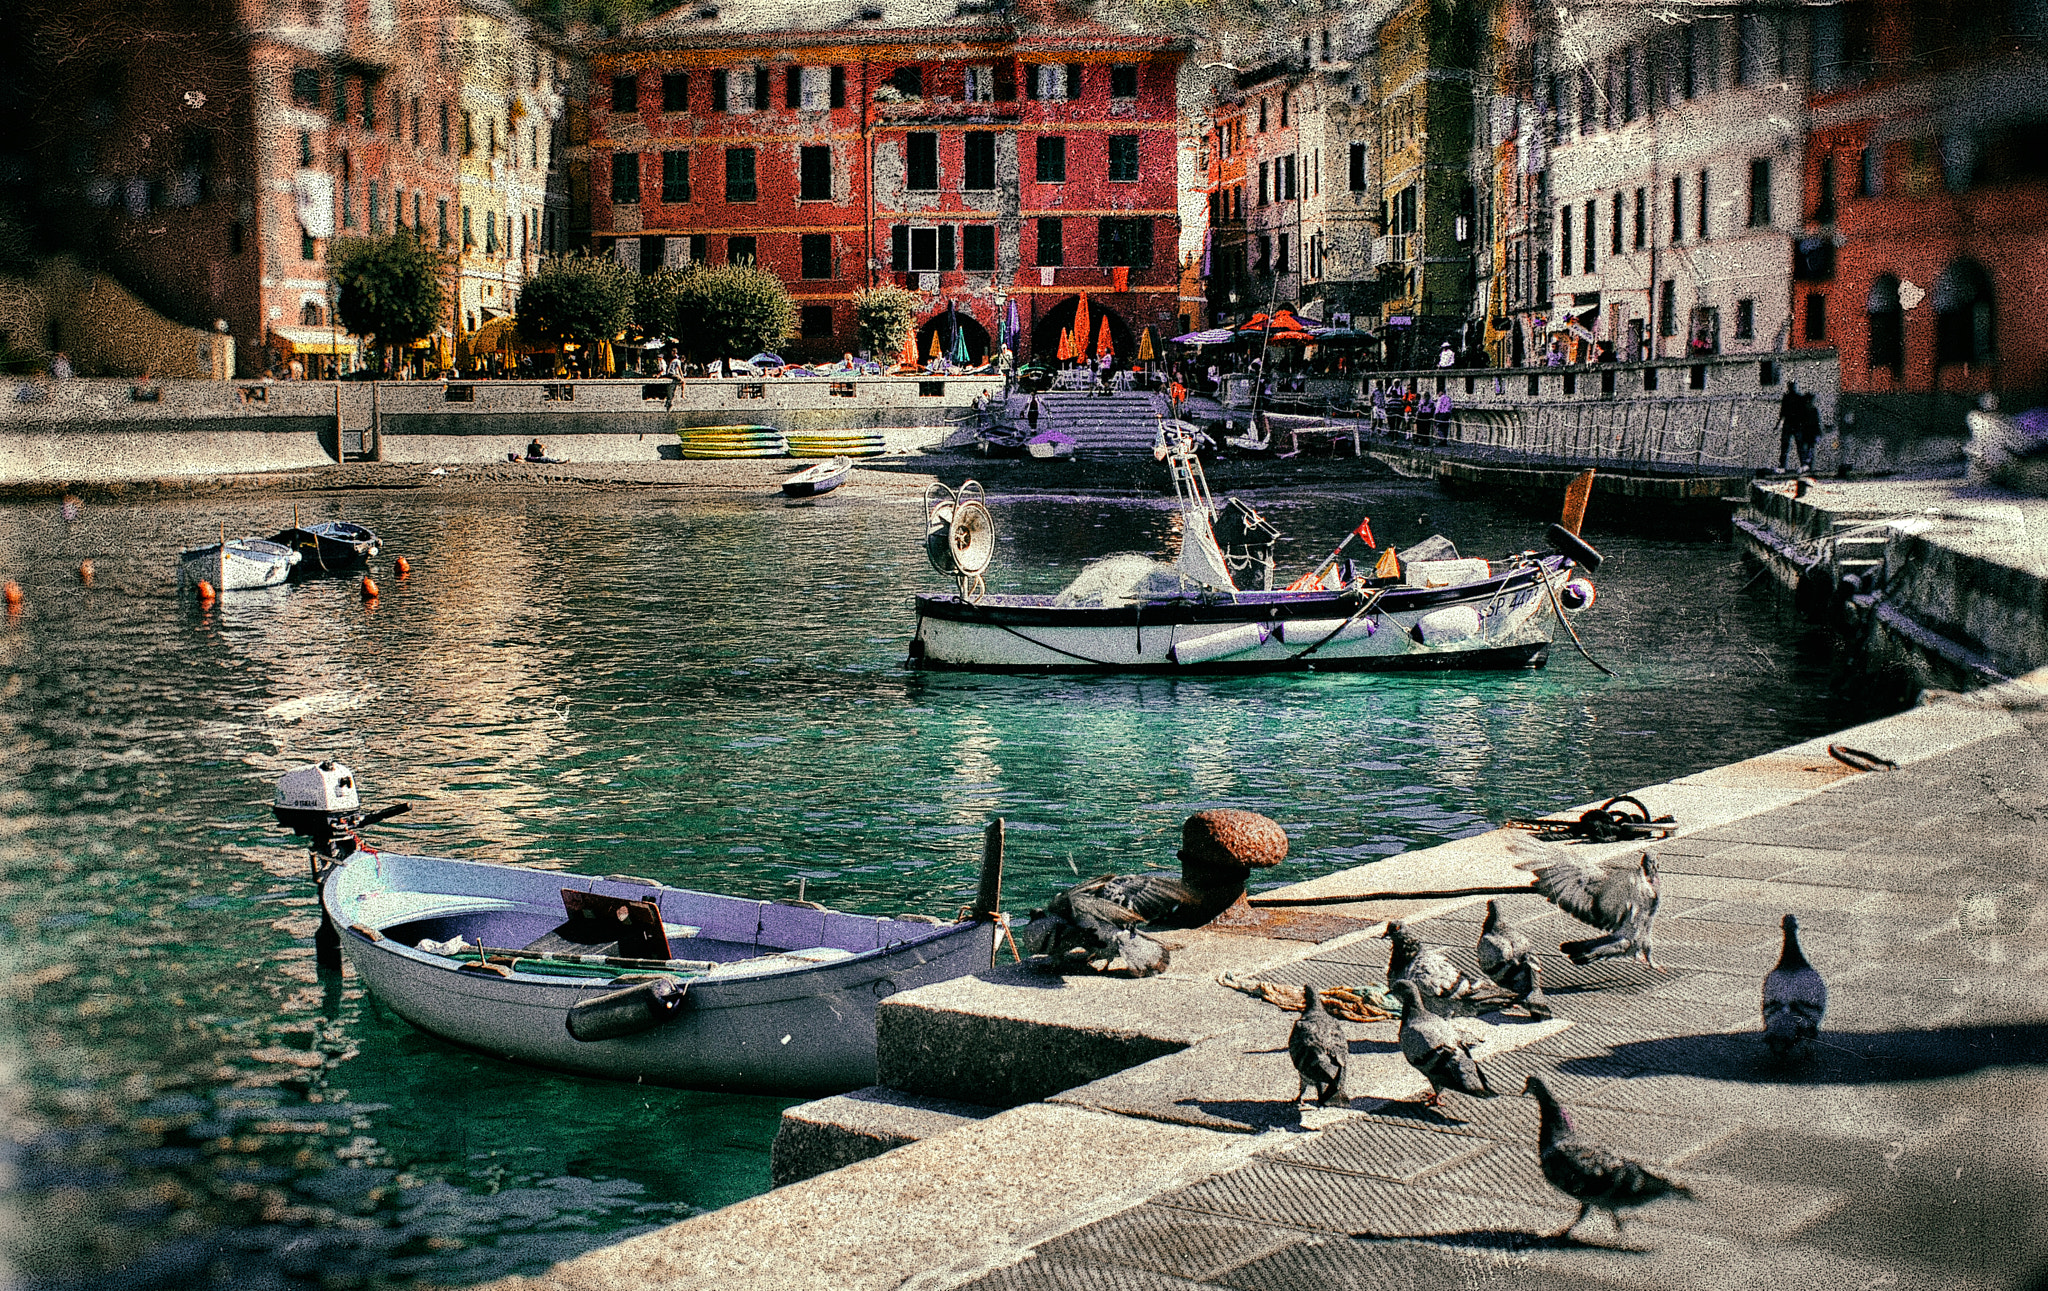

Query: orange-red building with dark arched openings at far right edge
1792;0;2048;439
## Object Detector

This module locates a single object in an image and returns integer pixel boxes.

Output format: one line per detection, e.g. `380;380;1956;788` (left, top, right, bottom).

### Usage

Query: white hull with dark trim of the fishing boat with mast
909;557;1567;672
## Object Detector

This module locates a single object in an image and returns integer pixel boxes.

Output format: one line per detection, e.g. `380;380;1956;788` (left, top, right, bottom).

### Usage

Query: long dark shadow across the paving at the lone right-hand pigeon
1559;1023;2048;1084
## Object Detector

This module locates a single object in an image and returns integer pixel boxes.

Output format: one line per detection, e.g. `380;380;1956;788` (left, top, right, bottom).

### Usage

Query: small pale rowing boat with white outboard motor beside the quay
272;762;1001;1094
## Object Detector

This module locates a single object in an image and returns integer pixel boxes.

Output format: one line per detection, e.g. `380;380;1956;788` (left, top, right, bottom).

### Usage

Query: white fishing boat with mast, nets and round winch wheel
909;432;1599;672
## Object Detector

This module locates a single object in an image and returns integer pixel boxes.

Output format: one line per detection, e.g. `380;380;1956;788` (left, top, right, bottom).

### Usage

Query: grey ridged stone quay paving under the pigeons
965;692;2048;1291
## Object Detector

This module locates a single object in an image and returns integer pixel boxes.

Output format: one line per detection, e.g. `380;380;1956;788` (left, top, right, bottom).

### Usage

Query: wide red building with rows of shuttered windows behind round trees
590;0;1184;361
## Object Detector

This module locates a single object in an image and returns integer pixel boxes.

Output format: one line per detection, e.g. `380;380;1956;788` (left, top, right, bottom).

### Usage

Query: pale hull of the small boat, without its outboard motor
322;852;995;1094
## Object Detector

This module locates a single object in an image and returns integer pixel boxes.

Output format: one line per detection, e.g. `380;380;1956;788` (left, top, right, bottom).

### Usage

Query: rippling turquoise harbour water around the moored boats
0;482;1866;1287
